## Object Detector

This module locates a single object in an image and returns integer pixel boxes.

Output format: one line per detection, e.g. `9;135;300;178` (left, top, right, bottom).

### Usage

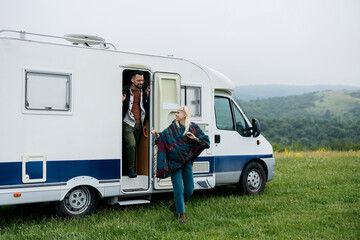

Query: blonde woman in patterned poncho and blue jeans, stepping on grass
151;106;210;224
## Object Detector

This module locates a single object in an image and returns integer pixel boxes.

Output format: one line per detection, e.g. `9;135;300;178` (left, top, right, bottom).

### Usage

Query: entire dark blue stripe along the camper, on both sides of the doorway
0;154;272;186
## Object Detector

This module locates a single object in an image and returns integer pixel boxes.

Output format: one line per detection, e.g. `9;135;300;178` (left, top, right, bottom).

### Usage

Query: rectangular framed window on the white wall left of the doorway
25;71;71;111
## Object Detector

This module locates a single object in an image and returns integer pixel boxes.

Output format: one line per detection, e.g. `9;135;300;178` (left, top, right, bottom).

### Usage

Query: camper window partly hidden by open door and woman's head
181;86;201;117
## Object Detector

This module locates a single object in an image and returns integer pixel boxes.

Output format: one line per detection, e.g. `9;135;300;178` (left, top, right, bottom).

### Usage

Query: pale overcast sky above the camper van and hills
0;0;360;86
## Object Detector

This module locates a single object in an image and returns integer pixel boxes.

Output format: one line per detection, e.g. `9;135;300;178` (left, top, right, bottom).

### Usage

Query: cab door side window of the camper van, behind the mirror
215;97;235;130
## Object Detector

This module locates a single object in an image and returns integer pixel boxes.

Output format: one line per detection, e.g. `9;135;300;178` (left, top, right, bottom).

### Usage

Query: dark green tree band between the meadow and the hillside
260;118;360;152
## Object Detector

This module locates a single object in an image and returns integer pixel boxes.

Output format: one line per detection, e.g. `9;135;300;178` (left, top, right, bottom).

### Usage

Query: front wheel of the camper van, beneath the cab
239;162;266;195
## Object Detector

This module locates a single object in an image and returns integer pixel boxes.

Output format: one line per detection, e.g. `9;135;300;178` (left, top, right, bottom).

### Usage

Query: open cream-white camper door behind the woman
153;72;181;189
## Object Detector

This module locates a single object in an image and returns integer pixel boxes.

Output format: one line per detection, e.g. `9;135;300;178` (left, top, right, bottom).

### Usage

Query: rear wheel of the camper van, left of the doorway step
55;186;99;218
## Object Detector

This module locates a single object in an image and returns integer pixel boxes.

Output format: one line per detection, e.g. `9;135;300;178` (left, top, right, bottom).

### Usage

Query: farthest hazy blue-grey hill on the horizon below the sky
233;85;360;101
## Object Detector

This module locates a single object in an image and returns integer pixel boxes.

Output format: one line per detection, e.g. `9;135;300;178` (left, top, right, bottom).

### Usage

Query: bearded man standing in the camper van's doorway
122;71;150;178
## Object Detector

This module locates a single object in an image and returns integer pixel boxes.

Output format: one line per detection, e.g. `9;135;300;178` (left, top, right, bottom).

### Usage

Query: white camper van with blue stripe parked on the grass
0;30;275;217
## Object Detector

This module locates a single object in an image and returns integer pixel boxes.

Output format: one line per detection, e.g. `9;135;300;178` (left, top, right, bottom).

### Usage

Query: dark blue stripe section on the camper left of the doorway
0;159;121;186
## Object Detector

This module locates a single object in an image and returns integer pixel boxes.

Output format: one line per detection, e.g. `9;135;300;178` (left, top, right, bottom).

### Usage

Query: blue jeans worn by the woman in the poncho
171;162;194;214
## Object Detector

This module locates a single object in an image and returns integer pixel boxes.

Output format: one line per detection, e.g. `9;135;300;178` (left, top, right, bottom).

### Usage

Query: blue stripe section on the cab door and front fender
215;154;273;173
